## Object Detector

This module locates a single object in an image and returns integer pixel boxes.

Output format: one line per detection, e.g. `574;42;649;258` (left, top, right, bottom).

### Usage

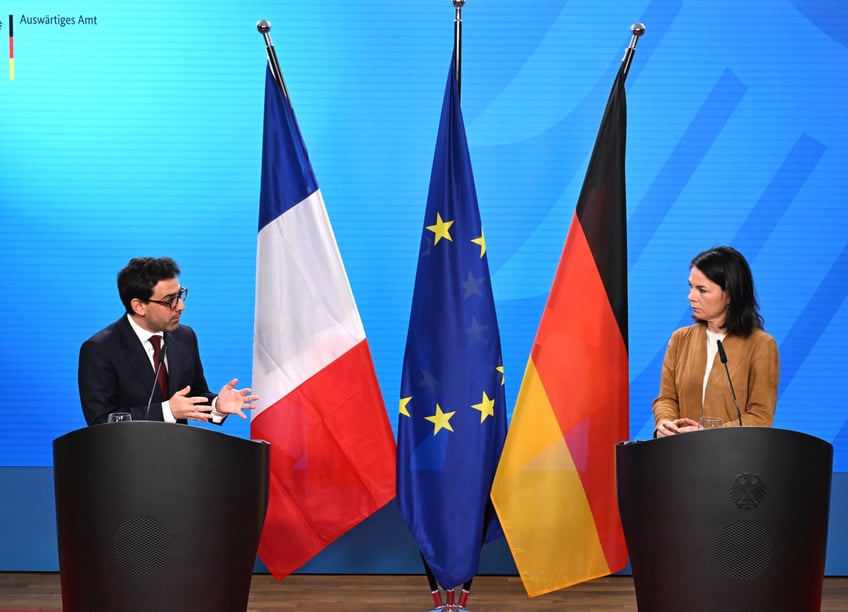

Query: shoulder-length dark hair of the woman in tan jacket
691;246;763;338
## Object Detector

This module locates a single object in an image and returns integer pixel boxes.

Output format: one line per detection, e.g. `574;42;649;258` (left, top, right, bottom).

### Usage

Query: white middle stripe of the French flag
253;190;365;418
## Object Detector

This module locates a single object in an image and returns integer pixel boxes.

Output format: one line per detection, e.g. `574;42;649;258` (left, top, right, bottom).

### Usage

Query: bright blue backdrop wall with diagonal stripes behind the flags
0;0;848;572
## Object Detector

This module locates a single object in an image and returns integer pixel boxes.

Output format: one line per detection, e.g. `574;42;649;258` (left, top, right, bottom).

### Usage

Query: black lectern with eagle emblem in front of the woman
616;427;833;612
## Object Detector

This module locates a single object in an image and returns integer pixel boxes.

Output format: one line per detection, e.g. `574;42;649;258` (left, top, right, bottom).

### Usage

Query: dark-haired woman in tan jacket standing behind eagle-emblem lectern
653;246;780;437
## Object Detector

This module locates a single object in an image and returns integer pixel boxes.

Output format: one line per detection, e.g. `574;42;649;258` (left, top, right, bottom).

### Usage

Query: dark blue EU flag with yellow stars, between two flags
397;55;506;589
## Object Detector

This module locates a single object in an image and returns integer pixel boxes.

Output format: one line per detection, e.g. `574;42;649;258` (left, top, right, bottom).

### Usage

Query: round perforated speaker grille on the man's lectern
112;516;171;575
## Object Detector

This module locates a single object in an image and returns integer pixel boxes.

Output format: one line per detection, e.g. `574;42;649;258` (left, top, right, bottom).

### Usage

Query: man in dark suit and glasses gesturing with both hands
78;257;258;425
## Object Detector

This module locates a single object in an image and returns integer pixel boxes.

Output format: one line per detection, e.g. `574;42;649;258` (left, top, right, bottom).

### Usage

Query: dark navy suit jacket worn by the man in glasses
78;315;215;425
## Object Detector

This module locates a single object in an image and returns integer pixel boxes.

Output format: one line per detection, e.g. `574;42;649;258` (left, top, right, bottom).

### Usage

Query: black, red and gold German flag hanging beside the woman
492;62;629;597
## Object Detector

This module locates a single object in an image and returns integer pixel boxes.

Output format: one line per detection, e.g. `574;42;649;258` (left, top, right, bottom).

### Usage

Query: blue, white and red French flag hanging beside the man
251;68;396;580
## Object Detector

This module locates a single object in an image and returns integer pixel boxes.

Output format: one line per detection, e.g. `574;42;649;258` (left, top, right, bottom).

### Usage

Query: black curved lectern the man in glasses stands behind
53;421;269;612
